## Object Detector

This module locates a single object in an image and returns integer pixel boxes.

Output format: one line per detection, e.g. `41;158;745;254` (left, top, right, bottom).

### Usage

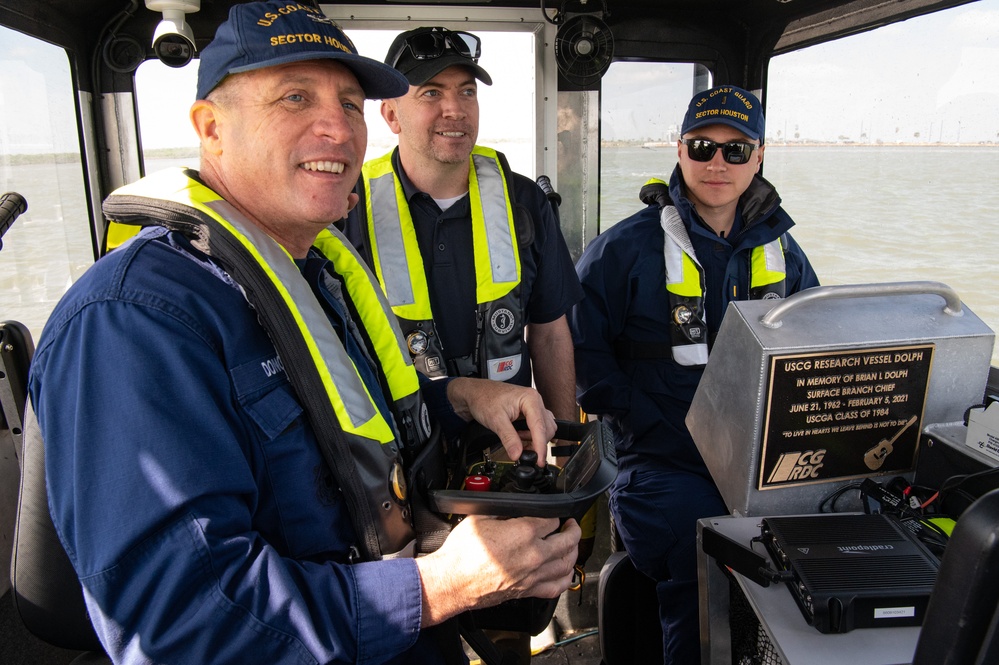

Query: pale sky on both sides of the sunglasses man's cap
601;0;999;142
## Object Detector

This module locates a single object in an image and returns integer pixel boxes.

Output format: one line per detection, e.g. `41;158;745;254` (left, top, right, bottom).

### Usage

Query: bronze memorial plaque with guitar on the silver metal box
758;344;934;490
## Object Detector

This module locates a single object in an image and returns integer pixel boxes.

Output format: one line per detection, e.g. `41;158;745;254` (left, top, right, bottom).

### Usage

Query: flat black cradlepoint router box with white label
761;514;939;633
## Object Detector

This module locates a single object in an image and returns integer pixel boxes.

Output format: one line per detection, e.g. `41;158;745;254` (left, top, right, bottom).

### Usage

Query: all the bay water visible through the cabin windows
0;144;999;366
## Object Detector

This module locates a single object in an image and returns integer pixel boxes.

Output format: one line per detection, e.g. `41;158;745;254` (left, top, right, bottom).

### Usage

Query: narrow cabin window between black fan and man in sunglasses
599;62;710;231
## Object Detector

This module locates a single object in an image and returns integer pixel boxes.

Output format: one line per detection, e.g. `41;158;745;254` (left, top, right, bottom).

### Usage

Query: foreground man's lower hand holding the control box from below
416;515;580;628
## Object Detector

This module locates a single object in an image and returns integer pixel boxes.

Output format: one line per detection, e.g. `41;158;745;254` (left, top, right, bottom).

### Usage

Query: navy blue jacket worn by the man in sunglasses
569;167;819;476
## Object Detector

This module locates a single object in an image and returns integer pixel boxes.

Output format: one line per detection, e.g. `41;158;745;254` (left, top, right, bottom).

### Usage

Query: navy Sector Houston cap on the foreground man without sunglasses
198;0;409;99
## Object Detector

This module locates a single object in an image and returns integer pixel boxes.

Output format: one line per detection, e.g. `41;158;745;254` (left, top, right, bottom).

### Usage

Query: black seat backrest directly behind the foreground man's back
10;403;102;651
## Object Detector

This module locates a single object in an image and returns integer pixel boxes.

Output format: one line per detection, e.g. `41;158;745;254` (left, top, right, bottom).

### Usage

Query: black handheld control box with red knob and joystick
427;420;617;521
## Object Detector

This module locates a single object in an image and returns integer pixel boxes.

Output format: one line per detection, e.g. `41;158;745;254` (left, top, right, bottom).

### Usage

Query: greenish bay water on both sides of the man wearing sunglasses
600;144;999;366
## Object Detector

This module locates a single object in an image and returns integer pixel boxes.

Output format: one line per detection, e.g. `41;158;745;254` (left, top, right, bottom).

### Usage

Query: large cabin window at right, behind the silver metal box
763;0;999;365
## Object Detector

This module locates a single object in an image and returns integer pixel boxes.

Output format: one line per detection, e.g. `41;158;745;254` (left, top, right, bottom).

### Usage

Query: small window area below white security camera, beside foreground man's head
135;59;200;174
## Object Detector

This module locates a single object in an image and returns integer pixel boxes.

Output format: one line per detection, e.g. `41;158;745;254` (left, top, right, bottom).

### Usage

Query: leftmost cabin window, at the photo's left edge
0;27;94;340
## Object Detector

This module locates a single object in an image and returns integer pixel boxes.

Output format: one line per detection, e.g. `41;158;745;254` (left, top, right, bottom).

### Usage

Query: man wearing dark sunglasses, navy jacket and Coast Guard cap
570;85;818;663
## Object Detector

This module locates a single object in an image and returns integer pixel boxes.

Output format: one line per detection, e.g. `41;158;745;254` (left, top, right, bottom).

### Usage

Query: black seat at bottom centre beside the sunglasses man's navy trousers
597;552;663;665
